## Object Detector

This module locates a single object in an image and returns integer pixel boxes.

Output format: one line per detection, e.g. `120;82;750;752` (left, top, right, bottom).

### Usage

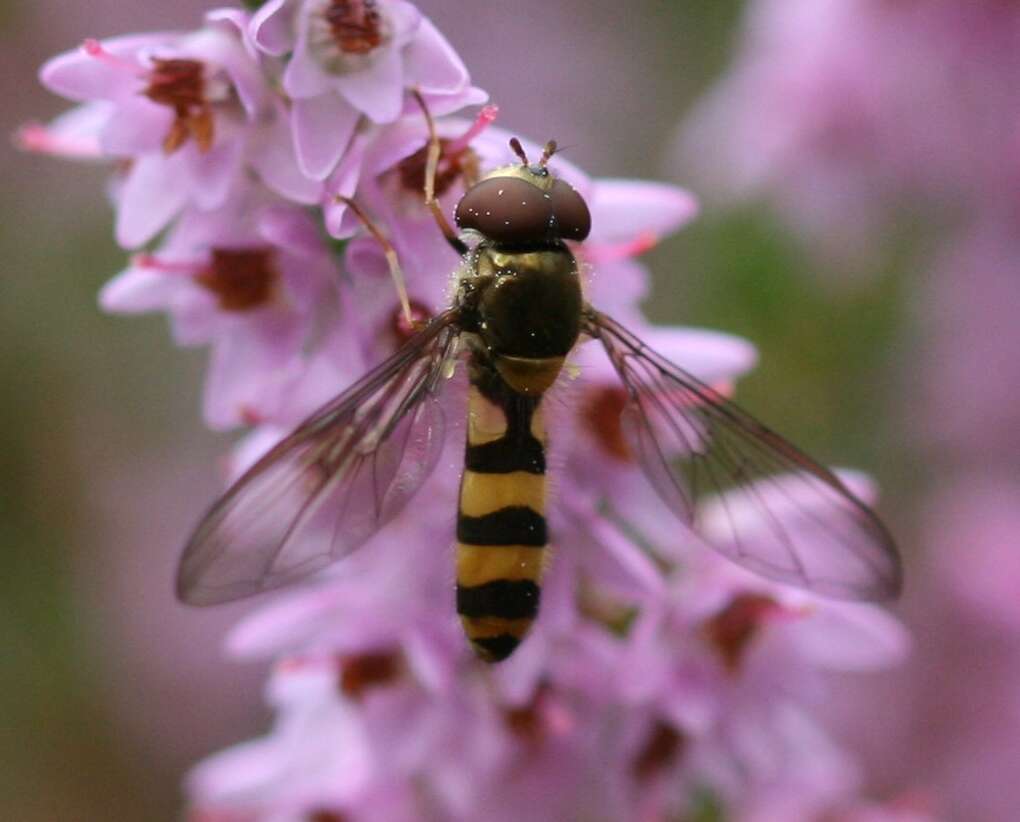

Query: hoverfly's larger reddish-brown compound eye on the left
454;177;553;245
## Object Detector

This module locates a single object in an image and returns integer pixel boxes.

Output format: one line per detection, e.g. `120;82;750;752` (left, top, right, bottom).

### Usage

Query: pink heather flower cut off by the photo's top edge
251;0;485;179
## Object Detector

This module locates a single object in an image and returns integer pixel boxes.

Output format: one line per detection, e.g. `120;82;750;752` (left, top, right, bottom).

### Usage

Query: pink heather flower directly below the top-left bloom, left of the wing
100;191;337;428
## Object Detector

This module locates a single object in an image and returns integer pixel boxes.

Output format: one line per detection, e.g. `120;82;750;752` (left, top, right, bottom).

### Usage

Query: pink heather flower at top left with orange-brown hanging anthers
36;12;318;248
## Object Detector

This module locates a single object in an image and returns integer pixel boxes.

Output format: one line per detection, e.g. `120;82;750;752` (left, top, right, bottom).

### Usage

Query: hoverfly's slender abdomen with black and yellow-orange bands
457;377;559;662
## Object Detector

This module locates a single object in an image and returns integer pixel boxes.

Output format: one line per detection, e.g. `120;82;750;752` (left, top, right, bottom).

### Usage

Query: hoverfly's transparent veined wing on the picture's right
585;308;902;600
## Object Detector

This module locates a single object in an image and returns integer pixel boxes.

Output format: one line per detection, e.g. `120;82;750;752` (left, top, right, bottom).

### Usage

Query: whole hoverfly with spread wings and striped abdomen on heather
177;119;902;662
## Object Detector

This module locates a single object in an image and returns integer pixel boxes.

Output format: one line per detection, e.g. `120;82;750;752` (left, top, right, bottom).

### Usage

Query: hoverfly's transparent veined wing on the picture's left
176;309;457;605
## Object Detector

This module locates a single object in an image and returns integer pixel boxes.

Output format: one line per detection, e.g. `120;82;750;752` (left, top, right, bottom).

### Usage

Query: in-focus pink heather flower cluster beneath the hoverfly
31;0;909;822
